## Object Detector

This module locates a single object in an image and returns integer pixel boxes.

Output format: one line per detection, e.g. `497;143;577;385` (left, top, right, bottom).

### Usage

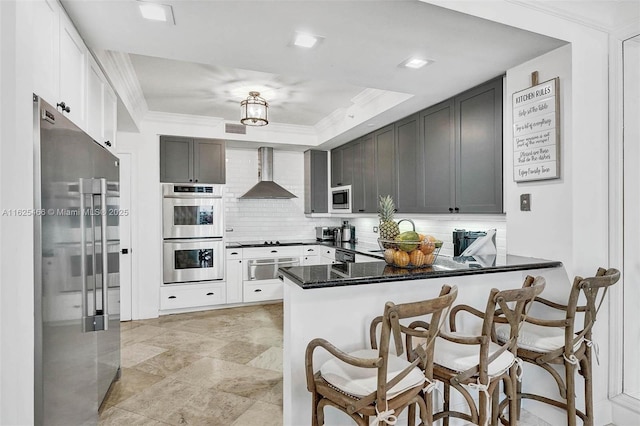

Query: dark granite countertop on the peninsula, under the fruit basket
280;255;562;289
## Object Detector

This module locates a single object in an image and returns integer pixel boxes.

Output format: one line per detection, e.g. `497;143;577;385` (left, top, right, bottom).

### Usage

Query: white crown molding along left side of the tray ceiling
93;50;149;127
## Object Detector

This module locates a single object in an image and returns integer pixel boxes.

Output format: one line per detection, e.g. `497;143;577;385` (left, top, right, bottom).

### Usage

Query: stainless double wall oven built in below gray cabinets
162;183;224;284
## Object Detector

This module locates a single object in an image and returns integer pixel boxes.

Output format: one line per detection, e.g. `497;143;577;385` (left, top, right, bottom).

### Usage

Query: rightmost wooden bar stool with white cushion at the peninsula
496;268;620;426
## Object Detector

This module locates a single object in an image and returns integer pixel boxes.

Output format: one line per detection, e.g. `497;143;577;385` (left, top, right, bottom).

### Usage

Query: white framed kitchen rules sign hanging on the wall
513;77;560;182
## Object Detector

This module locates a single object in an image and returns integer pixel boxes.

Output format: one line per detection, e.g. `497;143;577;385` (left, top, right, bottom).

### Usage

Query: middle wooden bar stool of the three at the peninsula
433;276;545;426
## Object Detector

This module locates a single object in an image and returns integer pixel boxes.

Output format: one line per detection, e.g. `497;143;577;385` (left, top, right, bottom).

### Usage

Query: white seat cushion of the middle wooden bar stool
433;333;514;376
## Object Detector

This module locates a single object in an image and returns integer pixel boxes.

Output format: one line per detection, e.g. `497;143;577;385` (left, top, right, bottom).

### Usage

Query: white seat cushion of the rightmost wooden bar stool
496;322;584;353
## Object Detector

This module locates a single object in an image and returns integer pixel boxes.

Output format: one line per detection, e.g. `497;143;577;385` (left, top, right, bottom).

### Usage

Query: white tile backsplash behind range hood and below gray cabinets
224;147;506;255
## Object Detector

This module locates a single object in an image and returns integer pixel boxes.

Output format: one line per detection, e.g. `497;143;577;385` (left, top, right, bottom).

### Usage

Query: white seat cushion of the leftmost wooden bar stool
320;349;425;399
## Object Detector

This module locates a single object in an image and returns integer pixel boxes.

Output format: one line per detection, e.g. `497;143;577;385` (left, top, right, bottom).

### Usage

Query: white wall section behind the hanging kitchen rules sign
503;45;572;272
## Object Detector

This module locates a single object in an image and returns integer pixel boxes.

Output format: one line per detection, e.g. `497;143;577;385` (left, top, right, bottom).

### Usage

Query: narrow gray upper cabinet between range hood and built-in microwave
304;149;329;213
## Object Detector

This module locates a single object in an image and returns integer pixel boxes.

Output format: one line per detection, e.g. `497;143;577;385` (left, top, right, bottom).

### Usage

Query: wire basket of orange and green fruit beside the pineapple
378;219;442;269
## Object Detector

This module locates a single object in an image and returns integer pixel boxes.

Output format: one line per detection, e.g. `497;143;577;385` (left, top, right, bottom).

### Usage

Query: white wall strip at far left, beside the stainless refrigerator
0;1;34;425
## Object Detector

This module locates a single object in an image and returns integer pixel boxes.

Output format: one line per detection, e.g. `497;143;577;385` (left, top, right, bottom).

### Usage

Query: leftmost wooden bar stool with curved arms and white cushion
305;286;458;426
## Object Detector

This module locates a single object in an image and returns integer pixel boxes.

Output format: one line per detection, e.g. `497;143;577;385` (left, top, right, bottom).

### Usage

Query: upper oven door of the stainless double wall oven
162;197;224;239
